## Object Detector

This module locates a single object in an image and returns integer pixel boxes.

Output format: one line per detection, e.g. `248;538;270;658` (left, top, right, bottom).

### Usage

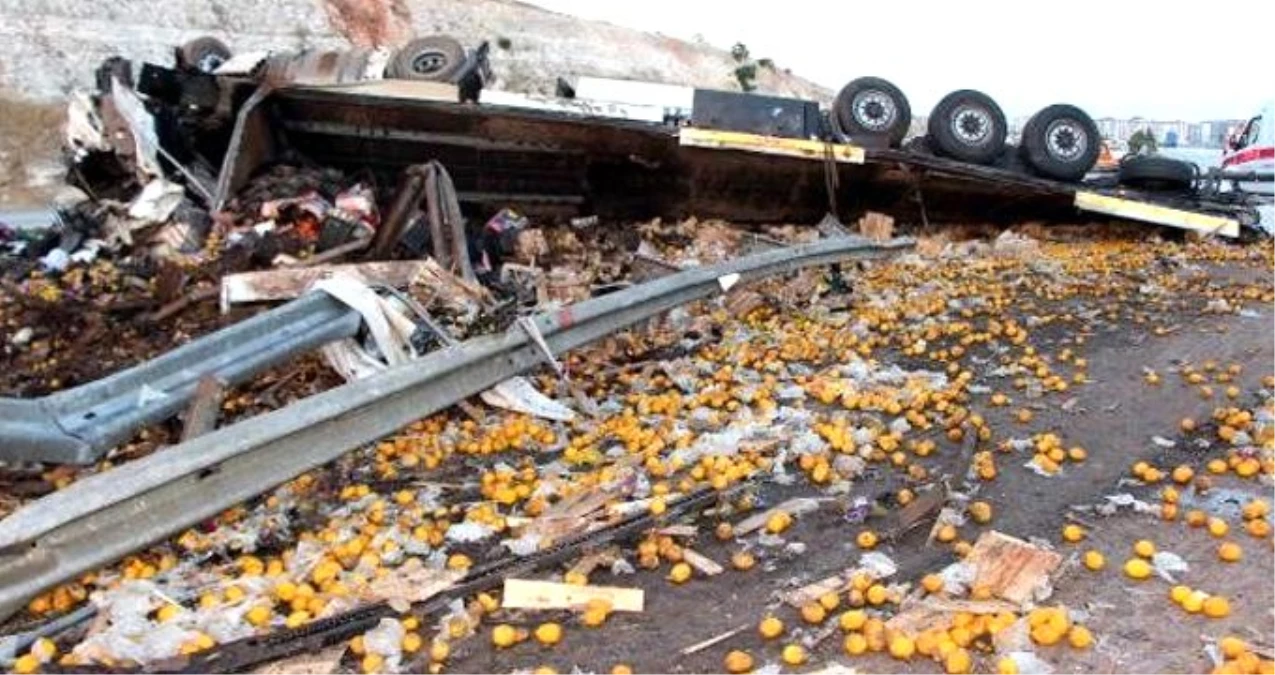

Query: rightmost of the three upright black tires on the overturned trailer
1019;103;1103;181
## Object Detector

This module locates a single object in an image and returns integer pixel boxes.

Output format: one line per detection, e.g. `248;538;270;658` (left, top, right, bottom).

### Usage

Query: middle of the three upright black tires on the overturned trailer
929;89;1009;165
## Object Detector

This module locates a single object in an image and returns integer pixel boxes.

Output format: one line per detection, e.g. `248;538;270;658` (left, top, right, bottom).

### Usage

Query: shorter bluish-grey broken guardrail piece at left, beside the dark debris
0;293;362;464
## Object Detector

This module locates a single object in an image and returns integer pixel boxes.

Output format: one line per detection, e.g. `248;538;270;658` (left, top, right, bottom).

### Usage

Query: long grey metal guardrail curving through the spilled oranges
0;237;914;619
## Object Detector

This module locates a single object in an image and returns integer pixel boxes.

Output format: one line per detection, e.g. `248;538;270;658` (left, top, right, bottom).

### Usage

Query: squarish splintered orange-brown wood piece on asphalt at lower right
965;531;1062;605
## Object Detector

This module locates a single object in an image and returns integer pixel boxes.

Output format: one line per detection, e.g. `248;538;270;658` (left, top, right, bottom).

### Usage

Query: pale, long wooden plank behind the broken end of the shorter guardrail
222;260;430;310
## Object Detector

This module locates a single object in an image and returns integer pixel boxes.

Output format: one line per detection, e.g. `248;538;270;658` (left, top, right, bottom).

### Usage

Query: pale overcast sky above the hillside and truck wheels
529;0;1275;121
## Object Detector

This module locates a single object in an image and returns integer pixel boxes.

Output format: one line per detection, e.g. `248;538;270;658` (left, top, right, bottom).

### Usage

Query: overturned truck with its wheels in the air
82;37;1258;241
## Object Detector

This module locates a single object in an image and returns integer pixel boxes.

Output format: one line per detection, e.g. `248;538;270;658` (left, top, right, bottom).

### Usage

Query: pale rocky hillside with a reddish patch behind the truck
0;0;830;101
